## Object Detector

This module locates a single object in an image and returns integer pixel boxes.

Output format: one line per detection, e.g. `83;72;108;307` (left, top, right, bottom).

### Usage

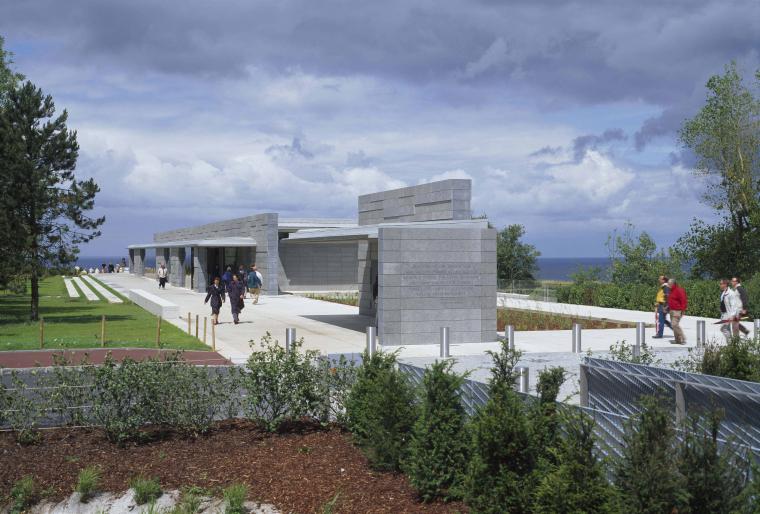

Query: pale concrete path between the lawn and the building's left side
98;273;374;362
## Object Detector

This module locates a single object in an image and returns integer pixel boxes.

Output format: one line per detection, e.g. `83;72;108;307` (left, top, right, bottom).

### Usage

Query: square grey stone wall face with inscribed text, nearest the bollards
377;225;496;346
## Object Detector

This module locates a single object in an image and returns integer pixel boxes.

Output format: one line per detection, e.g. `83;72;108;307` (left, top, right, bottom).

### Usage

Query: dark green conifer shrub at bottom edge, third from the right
533;410;622;514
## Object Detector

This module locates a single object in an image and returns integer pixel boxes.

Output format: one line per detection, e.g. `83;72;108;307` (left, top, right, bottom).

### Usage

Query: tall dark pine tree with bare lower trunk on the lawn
0;82;105;320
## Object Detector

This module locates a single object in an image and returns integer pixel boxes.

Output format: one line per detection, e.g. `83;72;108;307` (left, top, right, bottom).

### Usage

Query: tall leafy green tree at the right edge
679;62;760;278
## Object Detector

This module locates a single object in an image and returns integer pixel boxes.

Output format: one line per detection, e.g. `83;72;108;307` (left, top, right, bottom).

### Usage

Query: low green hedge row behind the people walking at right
557;276;760;318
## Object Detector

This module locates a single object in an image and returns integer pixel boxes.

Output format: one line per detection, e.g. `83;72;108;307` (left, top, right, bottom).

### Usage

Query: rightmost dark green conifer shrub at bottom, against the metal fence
680;410;749;514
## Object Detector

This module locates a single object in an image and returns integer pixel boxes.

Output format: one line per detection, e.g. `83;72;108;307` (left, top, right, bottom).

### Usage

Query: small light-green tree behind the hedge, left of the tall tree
607;223;681;284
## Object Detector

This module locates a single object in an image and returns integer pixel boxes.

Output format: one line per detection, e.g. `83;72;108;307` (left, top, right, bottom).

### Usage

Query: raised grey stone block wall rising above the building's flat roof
359;179;472;225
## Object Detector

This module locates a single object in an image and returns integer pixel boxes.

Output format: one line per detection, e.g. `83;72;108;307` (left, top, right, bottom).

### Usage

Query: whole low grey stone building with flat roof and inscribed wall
129;179;496;345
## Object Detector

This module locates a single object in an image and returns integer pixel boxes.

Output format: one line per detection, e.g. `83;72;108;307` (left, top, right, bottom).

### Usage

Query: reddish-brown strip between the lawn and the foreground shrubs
0;348;230;368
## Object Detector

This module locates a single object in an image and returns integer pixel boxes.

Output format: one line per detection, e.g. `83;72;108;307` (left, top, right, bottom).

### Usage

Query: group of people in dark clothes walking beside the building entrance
203;264;263;325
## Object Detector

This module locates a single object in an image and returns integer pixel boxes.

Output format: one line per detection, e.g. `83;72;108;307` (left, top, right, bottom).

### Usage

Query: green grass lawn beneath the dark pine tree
0;277;210;351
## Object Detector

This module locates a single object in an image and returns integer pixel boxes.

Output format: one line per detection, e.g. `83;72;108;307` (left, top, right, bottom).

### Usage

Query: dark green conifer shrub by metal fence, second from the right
615;396;689;514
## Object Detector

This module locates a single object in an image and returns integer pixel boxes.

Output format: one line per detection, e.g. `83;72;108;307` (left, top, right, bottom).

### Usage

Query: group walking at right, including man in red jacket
652;275;749;344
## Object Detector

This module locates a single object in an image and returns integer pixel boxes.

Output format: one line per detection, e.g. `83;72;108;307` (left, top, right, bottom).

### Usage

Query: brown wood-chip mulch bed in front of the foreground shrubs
0;421;467;513
